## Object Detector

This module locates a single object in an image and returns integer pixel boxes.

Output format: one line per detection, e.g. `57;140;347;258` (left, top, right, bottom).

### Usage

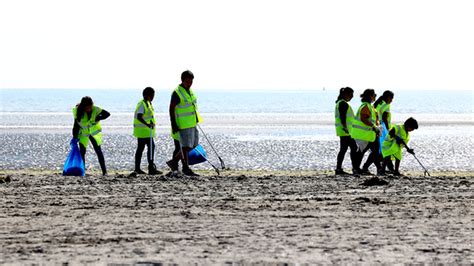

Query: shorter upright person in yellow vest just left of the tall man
133;87;161;175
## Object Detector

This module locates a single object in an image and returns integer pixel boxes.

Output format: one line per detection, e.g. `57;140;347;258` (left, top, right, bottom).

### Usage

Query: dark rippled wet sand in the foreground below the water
0;170;474;264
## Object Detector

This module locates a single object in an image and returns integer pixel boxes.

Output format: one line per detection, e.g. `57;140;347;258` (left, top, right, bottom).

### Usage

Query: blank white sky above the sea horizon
0;0;474;91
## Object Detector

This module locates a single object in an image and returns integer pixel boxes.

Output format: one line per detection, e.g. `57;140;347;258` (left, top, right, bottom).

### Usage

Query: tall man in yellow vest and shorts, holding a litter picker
167;70;201;176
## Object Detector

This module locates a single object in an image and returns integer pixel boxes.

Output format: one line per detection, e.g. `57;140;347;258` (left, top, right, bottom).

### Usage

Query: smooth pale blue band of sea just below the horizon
0;89;474;114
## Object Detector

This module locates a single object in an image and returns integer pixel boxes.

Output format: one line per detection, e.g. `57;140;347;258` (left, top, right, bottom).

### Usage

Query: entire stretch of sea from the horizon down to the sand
0;88;474;171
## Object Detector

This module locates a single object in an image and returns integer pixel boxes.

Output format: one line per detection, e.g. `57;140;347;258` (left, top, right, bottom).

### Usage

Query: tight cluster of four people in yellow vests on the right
335;87;418;175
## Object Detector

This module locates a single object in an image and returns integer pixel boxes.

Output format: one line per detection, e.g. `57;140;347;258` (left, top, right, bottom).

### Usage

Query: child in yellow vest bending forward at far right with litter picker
382;117;418;176
